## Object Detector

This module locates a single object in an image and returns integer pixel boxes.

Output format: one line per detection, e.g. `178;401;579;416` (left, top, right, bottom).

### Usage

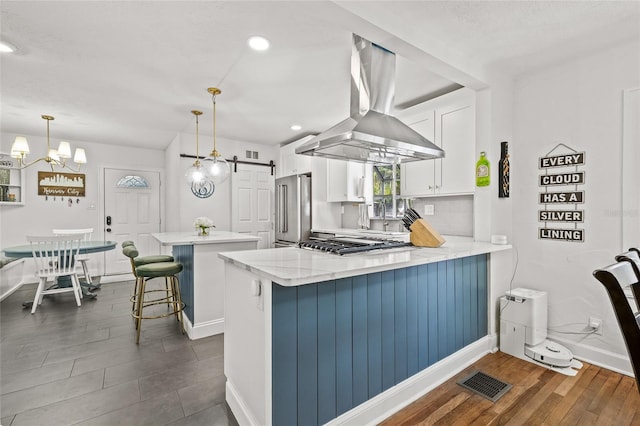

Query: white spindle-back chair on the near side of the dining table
27;235;82;314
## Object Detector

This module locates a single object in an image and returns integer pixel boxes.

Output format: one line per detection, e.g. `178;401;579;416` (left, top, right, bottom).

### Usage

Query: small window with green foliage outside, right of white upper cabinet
373;164;401;218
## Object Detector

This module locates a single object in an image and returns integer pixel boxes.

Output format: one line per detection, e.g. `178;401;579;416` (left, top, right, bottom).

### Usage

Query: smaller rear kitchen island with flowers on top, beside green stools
152;231;259;340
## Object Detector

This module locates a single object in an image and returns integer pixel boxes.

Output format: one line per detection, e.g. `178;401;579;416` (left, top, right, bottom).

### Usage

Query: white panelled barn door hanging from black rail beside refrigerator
231;164;275;249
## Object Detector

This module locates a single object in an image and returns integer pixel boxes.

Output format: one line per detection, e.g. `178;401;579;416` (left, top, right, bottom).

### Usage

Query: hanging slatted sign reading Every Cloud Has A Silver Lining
538;143;585;242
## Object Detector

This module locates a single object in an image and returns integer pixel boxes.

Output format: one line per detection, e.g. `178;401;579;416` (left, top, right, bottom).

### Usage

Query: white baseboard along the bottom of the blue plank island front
328;335;497;426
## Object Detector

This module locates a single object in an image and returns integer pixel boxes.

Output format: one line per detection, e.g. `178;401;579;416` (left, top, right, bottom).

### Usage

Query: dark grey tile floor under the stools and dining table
0;280;237;426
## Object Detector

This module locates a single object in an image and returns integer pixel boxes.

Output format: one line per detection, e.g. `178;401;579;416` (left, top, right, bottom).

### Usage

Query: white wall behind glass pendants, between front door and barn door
165;133;279;231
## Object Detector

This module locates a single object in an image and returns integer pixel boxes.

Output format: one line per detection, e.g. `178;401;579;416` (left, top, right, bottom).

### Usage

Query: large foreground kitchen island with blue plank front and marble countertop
219;238;511;425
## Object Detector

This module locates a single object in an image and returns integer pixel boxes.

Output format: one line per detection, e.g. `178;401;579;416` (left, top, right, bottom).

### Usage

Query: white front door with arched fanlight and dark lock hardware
103;168;160;275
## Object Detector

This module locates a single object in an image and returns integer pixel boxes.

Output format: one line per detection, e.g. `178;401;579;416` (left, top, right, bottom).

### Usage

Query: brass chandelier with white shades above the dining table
10;115;87;172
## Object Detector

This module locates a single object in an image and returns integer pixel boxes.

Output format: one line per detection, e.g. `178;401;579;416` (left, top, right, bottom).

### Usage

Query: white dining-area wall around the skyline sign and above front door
0;133;164;273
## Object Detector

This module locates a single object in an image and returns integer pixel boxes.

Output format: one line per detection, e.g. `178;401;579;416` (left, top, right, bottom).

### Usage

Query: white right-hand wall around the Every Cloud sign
510;42;640;372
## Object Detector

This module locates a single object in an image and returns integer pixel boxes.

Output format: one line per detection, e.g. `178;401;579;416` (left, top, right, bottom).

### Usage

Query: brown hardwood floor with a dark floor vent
381;352;640;426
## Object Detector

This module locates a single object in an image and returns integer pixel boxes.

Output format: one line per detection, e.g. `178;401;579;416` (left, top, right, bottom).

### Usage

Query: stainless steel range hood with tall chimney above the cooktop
296;34;444;164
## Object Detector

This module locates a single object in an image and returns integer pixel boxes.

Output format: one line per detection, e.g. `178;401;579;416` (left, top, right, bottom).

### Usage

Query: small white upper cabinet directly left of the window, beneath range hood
327;160;366;202
